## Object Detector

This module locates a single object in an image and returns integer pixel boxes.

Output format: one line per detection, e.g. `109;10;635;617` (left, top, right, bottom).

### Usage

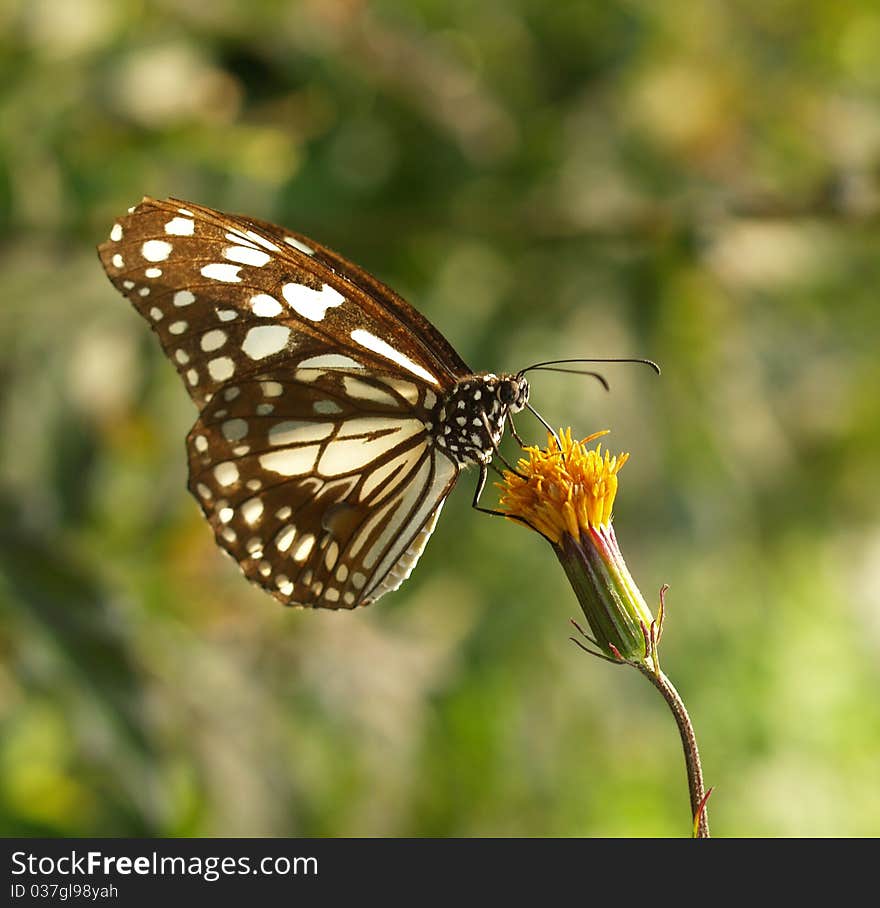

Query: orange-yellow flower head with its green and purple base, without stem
497;429;654;662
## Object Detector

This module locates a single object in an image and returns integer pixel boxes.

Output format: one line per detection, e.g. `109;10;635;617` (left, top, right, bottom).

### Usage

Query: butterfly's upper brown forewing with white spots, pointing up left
99;198;468;407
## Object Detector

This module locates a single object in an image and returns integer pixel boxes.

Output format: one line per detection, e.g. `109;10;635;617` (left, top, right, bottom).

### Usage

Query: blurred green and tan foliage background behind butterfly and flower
0;0;880;836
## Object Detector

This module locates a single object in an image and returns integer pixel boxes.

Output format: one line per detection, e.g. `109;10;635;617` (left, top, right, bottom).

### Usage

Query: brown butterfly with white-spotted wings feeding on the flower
98;197;531;608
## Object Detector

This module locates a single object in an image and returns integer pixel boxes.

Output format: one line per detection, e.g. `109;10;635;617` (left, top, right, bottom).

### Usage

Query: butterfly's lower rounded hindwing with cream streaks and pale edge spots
187;369;458;608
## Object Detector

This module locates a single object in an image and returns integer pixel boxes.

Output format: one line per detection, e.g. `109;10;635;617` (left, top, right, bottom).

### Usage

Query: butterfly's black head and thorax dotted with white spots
431;372;529;466
